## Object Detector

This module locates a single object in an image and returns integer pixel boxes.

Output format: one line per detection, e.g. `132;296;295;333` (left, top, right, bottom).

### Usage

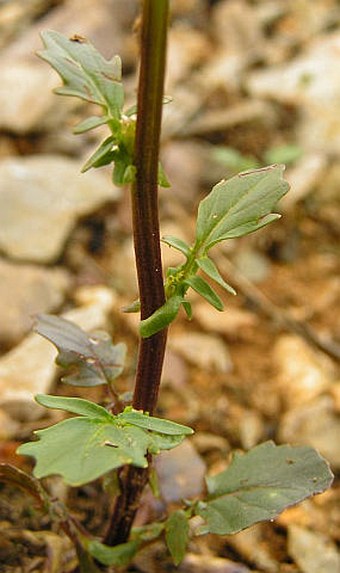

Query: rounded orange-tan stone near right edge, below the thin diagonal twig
273;334;333;408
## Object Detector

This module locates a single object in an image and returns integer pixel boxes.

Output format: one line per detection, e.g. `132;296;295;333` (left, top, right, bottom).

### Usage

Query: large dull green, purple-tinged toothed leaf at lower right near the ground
196;442;333;535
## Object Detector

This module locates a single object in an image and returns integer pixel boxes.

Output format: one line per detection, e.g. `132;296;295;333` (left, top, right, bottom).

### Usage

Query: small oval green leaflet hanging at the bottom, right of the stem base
165;509;189;565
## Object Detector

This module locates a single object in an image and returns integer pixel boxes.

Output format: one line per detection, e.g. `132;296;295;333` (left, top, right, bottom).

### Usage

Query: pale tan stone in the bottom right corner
288;525;340;573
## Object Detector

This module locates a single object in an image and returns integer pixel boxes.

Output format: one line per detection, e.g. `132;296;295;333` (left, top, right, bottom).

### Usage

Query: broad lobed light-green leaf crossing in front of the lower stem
17;400;192;486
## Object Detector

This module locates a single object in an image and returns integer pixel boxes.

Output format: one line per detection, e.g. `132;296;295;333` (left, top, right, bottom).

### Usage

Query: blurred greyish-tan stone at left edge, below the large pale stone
0;259;71;347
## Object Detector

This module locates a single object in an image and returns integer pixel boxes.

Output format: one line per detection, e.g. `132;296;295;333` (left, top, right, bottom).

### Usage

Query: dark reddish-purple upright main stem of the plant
105;0;169;545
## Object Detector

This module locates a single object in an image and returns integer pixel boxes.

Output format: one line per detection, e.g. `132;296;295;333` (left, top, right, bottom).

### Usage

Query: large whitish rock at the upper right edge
247;31;340;153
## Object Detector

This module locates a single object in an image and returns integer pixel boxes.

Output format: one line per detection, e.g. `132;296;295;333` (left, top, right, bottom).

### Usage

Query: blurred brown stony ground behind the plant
0;0;340;573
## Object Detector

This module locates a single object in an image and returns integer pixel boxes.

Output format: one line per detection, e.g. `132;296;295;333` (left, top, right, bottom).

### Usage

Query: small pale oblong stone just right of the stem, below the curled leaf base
169;332;232;372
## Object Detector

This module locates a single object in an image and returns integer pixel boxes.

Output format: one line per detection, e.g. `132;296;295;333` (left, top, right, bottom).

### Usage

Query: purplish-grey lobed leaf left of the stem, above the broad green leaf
35;314;126;386
